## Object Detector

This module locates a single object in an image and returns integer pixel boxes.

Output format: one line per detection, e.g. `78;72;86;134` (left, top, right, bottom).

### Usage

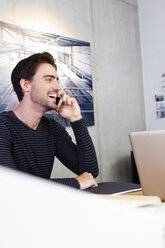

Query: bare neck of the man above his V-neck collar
13;101;45;130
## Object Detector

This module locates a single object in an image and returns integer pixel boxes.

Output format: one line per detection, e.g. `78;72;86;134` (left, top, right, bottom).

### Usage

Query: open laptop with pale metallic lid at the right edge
129;130;165;201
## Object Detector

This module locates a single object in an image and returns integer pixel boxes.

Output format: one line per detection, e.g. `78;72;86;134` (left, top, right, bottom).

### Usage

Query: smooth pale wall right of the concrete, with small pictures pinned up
139;0;165;130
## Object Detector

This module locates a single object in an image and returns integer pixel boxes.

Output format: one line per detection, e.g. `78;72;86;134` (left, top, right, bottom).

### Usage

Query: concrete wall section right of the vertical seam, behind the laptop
92;0;145;181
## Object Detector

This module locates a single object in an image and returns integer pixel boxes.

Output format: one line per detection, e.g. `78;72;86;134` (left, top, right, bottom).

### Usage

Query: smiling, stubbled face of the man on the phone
30;63;61;111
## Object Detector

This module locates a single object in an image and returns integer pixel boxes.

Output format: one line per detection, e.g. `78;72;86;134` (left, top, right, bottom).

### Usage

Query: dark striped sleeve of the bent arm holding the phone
53;119;99;178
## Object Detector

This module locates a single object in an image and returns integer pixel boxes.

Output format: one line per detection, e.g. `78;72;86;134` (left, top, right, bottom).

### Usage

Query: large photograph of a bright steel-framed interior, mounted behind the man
0;22;94;126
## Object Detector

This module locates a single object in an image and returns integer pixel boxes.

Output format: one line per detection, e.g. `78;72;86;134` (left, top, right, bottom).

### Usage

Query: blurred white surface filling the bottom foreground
0;168;165;248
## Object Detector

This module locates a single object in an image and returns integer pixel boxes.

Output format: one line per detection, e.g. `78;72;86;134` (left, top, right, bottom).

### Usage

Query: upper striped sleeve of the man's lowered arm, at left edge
0;121;16;169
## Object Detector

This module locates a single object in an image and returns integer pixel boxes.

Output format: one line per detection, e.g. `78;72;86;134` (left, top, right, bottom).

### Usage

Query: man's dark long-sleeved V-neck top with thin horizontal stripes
0;111;98;188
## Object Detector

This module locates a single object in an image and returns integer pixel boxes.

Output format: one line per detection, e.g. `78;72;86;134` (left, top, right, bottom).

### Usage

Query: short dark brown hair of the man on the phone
11;52;57;101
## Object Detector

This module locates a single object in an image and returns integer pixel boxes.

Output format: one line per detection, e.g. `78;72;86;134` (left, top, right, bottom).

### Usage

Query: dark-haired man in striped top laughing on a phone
0;52;98;189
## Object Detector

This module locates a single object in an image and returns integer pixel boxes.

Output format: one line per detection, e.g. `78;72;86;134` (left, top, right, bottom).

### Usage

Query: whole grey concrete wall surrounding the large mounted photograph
0;0;145;181
